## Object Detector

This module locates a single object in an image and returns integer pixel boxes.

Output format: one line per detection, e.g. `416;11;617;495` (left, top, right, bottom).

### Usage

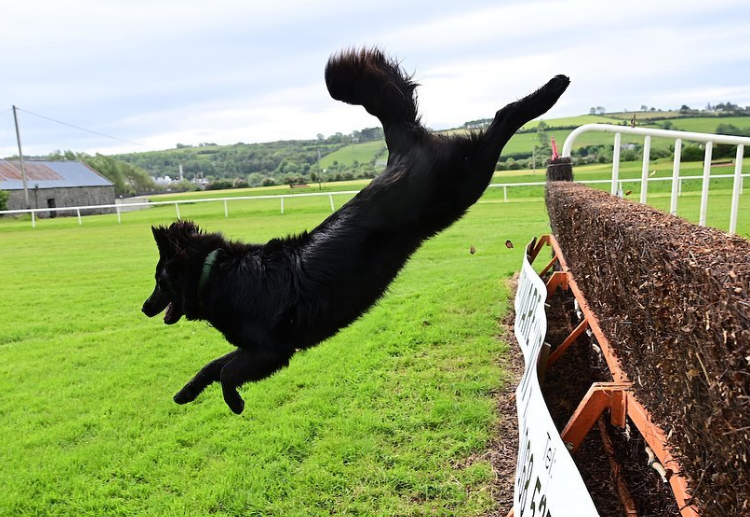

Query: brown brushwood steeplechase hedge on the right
547;181;750;517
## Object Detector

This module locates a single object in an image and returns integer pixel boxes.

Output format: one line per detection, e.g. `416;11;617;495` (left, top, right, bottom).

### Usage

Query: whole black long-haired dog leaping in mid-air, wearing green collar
143;49;569;414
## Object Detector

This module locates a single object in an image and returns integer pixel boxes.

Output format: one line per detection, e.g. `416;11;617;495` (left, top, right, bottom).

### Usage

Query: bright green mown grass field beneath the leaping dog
0;166;750;516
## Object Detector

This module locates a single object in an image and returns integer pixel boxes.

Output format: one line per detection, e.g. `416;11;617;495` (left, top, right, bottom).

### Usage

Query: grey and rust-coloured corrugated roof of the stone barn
0;160;113;190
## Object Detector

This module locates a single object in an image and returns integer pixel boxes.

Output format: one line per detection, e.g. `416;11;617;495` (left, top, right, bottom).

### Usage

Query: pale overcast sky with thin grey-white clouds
0;0;750;157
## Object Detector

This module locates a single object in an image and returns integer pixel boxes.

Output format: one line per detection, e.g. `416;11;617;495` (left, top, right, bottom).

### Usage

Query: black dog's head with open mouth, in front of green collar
142;221;200;325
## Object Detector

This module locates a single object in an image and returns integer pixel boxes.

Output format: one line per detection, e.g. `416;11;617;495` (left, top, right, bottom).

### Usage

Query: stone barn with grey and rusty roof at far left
0;160;115;217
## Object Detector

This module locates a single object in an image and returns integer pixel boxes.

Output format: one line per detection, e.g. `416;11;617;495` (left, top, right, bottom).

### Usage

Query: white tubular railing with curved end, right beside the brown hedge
562;124;750;234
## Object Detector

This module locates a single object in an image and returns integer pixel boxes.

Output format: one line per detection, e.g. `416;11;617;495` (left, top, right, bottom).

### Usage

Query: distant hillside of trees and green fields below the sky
20;108;750;195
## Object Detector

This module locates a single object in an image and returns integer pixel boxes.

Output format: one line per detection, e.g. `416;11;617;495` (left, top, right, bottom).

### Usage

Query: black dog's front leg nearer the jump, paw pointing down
220;348;289;415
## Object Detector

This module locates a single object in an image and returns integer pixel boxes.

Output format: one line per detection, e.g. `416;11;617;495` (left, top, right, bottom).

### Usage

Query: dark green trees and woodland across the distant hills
7;109;750;198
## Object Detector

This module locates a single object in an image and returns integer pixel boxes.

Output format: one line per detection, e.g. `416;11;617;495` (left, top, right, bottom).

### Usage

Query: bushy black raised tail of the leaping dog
325;48;419;131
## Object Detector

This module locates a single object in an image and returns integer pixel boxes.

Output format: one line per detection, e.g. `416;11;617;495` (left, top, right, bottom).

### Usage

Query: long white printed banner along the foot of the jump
513;246;599;517
